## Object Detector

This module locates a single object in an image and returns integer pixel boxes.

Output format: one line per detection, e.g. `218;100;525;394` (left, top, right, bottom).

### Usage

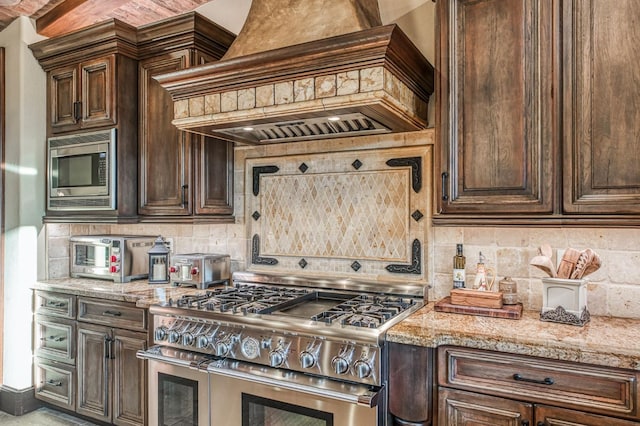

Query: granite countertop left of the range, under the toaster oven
32;278;203;308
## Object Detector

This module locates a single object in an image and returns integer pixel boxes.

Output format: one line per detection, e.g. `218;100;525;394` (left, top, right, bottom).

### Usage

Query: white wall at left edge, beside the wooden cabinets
0;17;46;389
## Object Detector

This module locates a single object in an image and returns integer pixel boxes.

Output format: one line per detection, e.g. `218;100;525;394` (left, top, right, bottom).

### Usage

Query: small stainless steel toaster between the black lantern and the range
169;253;231;289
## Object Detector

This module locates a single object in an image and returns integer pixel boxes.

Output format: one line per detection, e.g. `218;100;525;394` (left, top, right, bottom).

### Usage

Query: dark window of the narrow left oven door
158;373;198;426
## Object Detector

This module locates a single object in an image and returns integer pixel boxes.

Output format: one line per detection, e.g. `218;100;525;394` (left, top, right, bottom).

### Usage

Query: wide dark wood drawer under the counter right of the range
438;346;638;417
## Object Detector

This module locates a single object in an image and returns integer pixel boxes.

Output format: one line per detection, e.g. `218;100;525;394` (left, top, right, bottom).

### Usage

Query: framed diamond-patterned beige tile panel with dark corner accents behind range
245;147;431;282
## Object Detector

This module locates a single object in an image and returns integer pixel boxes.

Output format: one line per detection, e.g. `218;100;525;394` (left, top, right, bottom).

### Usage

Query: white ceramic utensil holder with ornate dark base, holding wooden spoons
540;278;590;326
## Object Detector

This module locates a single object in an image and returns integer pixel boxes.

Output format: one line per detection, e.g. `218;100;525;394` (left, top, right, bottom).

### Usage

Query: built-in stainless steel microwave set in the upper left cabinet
47;129;116;210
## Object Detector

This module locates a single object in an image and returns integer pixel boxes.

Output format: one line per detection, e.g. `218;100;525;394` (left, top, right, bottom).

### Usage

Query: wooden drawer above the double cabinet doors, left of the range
78;298;147;331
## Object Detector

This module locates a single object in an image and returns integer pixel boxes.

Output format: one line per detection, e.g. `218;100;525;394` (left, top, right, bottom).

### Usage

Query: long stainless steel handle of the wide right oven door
208;360;385;408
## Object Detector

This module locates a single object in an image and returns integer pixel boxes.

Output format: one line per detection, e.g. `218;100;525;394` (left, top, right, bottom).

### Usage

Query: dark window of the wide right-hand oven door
242;393;333;426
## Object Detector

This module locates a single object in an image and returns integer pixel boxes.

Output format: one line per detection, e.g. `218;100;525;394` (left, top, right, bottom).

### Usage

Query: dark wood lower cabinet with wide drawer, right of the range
437;346;640;426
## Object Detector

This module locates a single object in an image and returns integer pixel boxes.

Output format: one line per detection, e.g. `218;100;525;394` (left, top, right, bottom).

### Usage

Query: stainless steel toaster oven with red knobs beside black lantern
69;235;156;283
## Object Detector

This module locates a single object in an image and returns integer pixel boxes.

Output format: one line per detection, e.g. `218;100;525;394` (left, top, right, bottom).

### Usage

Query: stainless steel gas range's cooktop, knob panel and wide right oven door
138;272;425;426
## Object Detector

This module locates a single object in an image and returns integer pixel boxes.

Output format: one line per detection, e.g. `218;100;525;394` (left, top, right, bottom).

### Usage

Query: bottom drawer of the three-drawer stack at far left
35;358;76;411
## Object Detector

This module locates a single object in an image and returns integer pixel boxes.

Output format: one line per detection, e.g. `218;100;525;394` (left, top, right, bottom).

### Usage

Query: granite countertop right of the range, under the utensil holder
387;303;640;370
